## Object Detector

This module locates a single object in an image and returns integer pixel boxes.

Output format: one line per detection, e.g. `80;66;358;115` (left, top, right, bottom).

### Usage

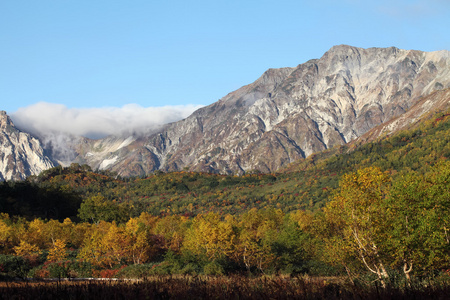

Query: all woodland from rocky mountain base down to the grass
0;109;450;286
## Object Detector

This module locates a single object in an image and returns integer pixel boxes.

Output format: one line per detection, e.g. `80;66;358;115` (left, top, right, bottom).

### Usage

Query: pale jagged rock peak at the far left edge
0;111;54;180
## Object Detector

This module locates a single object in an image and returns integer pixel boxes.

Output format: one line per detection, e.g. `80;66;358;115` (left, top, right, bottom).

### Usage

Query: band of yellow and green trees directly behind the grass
0;161;450;286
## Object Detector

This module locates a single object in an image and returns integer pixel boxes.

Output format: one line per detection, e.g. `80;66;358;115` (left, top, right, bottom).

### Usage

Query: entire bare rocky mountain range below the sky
0;45;450;179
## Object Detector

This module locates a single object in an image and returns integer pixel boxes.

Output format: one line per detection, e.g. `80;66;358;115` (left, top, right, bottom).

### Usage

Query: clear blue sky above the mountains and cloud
0;0;450;137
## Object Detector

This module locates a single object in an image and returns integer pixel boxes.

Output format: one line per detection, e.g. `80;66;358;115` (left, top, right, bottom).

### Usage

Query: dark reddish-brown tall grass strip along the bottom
0;276;450;300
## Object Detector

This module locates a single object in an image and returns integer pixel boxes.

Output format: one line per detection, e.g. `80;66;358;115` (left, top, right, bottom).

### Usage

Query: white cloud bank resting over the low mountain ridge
11;102;202;139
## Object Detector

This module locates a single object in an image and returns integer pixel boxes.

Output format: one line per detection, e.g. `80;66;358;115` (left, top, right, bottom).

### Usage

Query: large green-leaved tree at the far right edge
386;162;450;281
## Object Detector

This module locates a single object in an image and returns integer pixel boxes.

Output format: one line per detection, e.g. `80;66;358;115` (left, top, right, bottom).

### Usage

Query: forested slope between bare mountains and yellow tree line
0;109;450;222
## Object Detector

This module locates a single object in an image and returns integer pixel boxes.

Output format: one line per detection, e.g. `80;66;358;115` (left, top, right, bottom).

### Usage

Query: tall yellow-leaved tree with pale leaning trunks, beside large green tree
324;167;390;286
